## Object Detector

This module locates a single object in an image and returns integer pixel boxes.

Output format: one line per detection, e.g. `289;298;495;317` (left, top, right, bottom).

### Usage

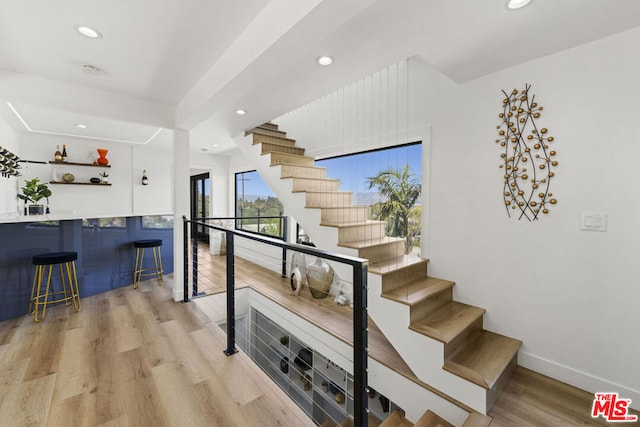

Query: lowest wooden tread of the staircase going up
444;330;522;389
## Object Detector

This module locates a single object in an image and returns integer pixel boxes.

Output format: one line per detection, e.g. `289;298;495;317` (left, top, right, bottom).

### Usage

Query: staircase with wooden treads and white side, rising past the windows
241;123;521;426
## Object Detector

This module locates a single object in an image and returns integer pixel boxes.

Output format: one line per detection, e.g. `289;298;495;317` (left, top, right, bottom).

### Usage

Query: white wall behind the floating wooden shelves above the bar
19;133;173;216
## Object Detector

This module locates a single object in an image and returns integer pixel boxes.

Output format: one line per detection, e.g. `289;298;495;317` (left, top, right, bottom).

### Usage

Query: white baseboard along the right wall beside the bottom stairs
518;351;640;410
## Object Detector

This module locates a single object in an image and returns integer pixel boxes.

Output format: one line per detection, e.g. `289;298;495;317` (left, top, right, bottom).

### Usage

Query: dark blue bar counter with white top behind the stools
0;213;173;321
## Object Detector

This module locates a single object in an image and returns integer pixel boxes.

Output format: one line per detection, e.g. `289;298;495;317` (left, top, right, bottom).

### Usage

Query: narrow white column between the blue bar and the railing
173;129;190;301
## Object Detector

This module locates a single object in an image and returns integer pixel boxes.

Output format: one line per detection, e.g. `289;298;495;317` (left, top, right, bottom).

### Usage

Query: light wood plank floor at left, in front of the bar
0;276;314;427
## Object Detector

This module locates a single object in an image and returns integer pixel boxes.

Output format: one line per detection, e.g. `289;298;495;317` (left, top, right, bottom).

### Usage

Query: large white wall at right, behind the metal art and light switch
422;30;640;407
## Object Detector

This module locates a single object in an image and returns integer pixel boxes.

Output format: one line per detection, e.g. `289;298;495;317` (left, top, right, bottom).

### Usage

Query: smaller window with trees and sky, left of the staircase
236;171;284;237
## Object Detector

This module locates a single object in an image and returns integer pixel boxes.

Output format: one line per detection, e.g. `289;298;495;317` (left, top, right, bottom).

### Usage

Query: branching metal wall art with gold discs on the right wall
496;84;558;221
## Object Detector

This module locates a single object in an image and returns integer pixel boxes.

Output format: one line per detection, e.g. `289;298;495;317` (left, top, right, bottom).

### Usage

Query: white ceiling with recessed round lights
0;0;640;153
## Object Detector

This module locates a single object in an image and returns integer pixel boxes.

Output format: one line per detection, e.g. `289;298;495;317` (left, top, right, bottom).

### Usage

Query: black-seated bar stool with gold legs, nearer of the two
29;252;80;323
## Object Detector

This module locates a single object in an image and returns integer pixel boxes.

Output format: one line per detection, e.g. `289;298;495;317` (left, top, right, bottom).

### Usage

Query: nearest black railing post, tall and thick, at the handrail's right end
353;264;369;427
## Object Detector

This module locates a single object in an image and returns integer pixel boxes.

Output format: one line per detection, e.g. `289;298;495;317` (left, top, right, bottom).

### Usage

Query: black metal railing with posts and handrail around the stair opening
182;215;369;427
